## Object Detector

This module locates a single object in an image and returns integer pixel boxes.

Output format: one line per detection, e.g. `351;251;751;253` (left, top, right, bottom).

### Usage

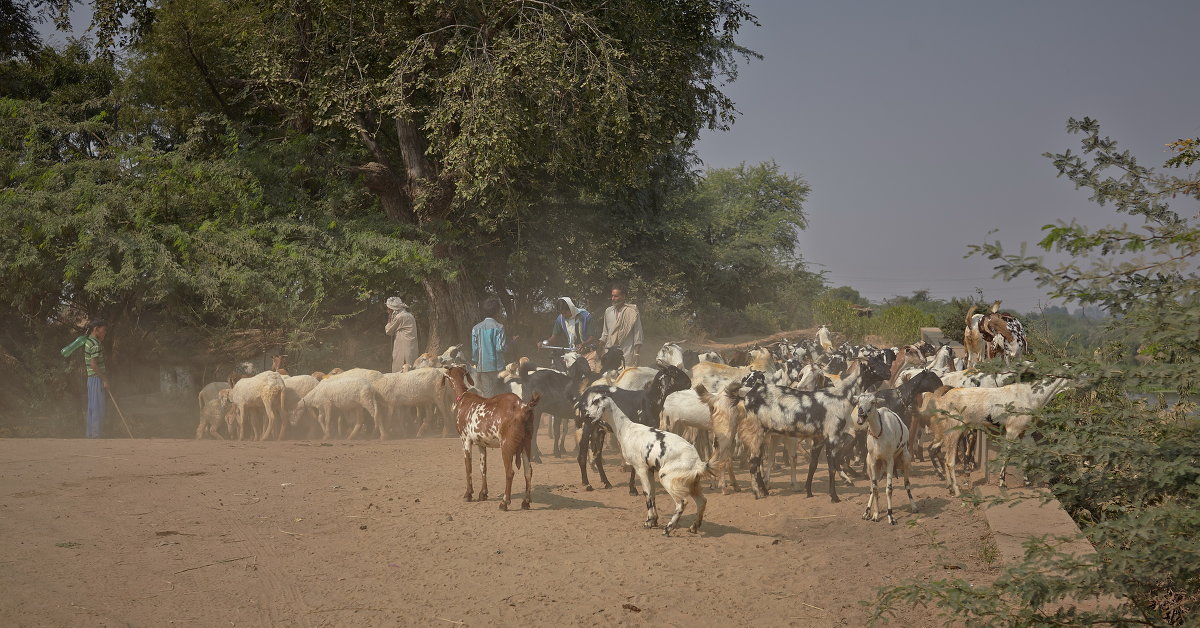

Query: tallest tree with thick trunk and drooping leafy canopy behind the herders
124;0;752;348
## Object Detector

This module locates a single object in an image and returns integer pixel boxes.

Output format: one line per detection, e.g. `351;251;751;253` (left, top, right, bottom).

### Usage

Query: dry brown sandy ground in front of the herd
0;430;996;627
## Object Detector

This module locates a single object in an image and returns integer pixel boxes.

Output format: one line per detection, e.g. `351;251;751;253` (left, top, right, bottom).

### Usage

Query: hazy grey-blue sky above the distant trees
698;0;1200;312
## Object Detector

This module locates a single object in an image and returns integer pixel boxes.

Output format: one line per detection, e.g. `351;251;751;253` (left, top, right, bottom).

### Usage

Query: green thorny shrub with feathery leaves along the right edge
877;118;1200;626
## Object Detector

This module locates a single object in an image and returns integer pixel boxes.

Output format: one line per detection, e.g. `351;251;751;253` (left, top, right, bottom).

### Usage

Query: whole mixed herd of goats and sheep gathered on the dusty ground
196;303;1070;536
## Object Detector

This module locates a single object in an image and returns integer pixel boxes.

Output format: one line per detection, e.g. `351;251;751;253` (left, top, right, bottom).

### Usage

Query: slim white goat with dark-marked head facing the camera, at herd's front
856;393;917;526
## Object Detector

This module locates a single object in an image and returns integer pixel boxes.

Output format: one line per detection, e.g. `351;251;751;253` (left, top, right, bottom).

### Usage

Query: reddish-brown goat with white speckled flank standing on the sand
445;366;541;510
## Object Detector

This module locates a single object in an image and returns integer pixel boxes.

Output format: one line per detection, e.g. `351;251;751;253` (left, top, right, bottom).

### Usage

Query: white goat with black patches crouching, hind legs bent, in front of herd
581;385;714;536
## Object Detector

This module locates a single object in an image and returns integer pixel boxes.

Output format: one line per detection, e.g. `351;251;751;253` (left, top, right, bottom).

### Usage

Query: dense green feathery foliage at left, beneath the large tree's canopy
0;44;443;412
